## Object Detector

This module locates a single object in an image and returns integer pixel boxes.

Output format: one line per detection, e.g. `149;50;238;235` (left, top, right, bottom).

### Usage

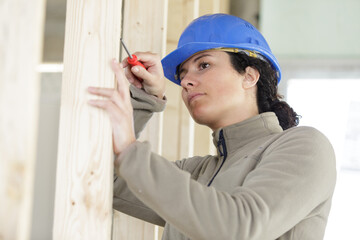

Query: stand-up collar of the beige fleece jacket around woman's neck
212;112;283;155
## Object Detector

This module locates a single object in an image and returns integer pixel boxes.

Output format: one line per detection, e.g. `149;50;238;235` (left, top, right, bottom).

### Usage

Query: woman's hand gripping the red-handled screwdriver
122;52;165;99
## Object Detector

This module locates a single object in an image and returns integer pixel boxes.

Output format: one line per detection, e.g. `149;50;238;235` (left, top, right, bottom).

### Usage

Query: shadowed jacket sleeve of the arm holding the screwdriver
113;85;166;226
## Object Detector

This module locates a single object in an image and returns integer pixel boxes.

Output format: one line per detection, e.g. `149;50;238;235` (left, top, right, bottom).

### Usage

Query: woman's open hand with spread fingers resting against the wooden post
88;59;136;155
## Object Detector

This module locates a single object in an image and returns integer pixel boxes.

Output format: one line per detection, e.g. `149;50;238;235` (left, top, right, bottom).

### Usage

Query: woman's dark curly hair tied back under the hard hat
227;52;300;130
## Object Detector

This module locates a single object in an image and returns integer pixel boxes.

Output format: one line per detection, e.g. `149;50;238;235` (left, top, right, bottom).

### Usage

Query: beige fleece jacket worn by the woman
114;88;336;240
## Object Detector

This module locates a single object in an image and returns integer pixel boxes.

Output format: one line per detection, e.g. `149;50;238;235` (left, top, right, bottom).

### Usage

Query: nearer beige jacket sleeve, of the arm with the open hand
118;128;336;240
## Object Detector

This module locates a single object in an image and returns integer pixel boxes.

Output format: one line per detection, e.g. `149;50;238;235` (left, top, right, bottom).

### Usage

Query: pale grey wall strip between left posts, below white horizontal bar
31;72;62;240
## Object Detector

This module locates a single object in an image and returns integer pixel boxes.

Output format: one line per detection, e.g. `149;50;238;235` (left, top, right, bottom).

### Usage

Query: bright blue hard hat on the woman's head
161;13;281;85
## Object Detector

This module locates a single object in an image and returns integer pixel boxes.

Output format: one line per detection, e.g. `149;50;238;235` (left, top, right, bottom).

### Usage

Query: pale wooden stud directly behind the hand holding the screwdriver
121;0;167;153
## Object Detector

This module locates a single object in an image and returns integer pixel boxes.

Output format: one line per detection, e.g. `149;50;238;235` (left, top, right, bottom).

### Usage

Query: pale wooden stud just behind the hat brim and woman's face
163;0;199;163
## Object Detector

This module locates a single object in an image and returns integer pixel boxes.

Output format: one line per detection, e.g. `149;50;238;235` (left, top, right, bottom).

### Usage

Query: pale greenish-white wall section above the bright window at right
260;0;360;58
